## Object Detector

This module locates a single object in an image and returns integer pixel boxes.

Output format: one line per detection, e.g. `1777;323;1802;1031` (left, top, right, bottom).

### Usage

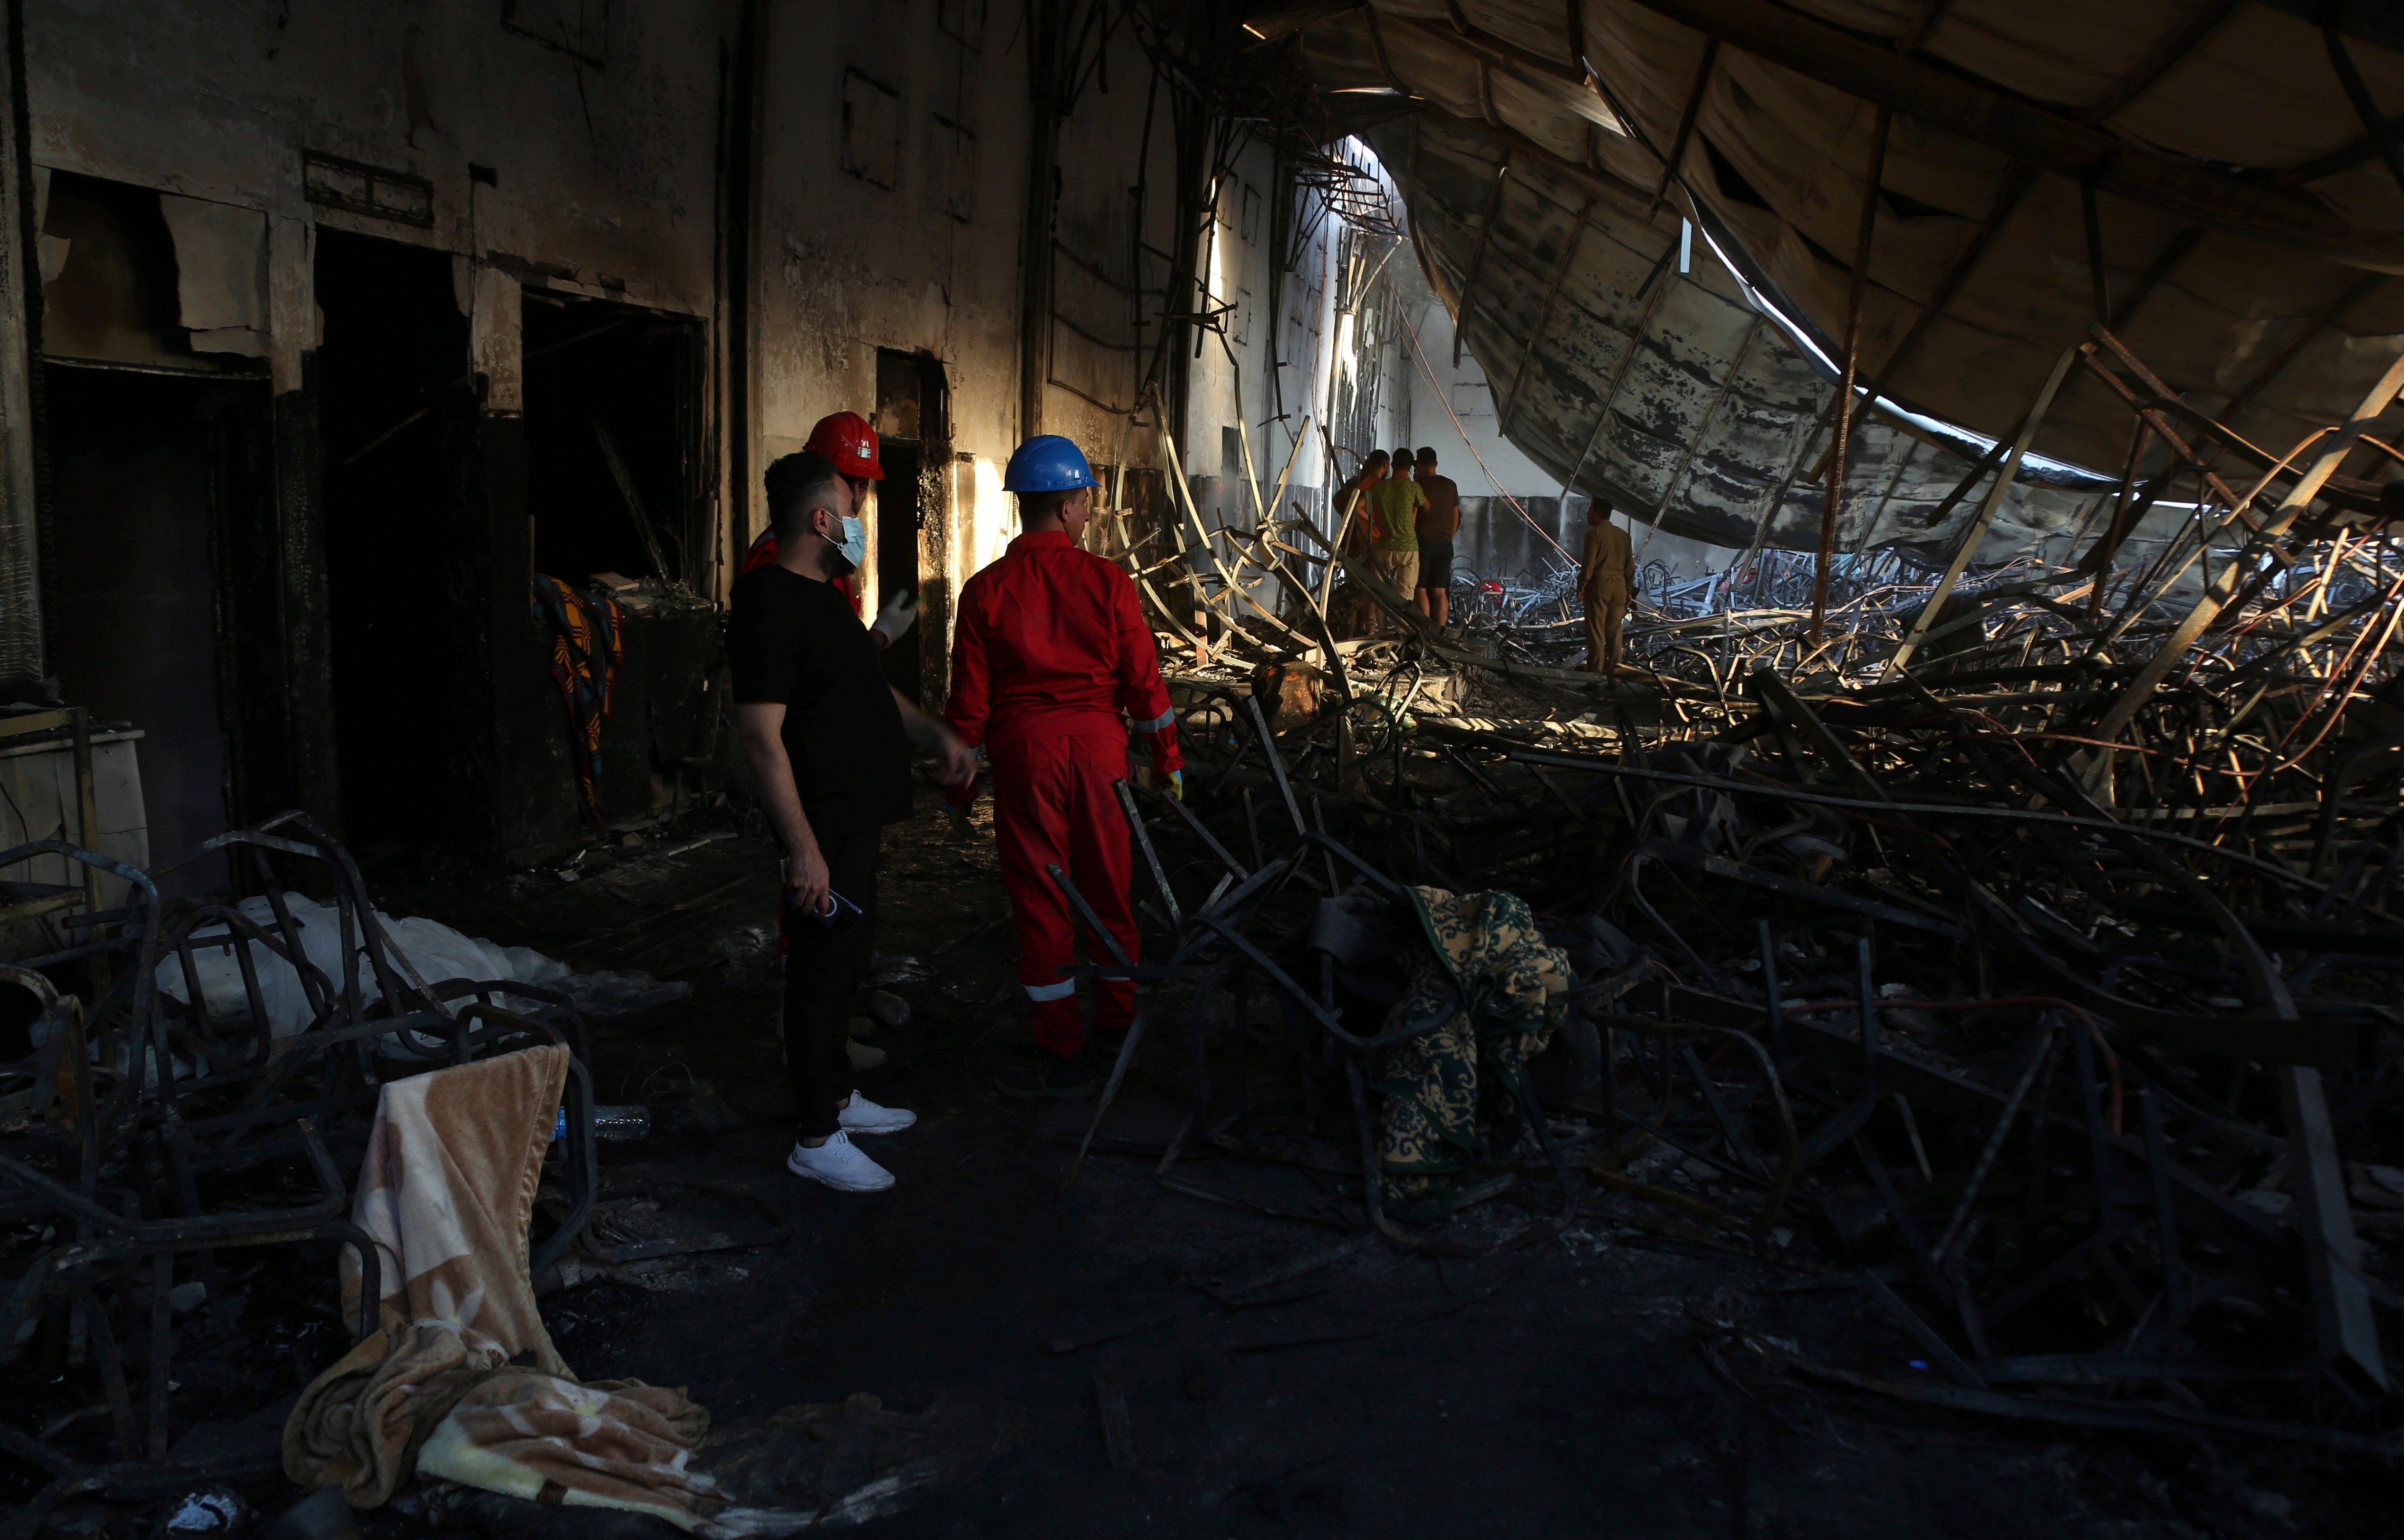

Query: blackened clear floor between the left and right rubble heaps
12;778;2397;1535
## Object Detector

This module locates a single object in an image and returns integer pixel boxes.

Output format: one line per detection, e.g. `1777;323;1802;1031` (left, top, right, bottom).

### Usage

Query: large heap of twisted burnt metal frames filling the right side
1091;507;2404;1458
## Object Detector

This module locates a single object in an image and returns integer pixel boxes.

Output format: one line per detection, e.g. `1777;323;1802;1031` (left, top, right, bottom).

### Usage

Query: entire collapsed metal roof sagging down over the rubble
1252;0;2404;558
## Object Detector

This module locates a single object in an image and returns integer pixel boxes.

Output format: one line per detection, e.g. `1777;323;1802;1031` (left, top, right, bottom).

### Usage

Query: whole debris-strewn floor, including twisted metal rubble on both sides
23;526;2404;1535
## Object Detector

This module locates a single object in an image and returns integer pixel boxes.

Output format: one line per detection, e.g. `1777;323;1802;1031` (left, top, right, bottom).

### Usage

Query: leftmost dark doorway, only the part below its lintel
43;363;267;896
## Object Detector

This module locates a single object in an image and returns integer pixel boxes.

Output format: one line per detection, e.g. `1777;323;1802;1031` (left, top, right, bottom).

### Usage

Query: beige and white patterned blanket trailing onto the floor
284;1045;721;1530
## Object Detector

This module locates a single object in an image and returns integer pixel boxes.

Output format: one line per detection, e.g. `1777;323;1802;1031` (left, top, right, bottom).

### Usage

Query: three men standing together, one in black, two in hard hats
726;413;1183;1192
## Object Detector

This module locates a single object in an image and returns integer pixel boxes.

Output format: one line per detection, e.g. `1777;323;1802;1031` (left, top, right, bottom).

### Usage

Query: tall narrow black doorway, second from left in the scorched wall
317;228;483;848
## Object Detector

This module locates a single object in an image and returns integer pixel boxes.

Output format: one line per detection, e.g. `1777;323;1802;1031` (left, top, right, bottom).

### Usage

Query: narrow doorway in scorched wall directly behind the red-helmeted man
875;348;952;704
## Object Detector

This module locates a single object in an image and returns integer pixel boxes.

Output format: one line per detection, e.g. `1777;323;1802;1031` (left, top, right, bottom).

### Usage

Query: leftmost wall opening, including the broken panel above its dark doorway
39;171;275;896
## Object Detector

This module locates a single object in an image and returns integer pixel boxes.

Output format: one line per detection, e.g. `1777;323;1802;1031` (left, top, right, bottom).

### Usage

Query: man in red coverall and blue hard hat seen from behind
947;433;1185;1096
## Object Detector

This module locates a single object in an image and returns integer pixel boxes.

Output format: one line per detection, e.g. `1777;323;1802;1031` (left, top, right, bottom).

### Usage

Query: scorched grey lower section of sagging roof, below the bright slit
1368;113;2099;555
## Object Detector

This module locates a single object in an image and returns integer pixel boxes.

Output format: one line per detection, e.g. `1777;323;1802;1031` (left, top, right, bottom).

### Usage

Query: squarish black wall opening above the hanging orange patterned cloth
524;291;709;588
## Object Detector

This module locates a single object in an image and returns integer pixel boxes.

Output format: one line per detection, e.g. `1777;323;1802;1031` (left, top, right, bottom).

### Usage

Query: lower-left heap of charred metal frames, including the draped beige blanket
0;815;1024;1535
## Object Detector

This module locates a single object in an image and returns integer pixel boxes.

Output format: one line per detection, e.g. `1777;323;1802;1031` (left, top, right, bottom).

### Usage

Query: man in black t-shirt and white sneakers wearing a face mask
726;452;976;1192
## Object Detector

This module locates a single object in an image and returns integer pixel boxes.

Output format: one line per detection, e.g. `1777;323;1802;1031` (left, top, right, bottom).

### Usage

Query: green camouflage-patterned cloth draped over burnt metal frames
1370;886;1572;1203
